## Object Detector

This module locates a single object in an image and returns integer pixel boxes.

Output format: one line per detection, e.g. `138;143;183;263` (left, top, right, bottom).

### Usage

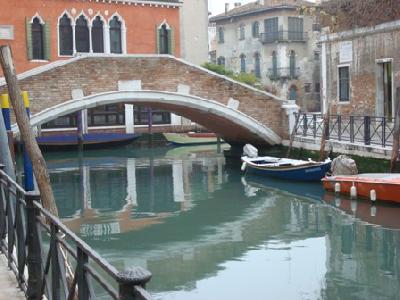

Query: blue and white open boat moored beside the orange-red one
242;156;331;181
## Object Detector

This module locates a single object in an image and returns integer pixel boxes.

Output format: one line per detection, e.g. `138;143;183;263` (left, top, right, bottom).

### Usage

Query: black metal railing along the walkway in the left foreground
0;165;151;300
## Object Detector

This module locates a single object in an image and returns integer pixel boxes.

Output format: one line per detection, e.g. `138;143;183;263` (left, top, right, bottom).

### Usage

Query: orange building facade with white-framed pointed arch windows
0;0;203;133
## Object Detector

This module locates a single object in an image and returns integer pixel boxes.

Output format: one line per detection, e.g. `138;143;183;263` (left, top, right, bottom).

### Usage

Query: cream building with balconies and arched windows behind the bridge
209;0;320;111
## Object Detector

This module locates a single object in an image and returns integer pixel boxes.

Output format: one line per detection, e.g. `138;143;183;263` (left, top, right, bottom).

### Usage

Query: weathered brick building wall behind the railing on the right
321;20;400;118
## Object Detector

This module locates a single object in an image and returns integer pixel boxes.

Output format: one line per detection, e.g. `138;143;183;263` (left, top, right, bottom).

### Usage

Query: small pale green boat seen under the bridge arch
163;132;223;146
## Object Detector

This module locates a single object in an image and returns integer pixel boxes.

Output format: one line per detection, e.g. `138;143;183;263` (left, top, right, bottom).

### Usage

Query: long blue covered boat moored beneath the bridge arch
36;133;139;150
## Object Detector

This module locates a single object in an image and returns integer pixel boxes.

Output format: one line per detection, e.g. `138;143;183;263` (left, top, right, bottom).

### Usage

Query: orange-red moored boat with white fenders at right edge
322;173;400;203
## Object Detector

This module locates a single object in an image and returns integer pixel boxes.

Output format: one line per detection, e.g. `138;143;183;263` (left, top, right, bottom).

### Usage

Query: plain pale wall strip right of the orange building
181;0;208;65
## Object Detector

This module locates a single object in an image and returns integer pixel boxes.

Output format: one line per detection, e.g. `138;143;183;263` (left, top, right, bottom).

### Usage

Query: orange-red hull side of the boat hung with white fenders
322;177;400;203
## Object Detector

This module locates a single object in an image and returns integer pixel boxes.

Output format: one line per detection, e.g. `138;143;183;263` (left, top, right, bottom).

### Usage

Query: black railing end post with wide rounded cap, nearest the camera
117;267;152;300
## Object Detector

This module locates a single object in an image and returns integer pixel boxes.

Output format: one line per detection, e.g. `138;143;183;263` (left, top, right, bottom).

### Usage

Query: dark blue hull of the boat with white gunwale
247;162;331;181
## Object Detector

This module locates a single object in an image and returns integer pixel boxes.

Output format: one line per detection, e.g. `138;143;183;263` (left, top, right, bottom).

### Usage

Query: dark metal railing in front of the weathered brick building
295;114;394;148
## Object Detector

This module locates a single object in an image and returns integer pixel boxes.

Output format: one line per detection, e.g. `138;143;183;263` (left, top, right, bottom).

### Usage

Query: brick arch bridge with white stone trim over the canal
0;55;297;145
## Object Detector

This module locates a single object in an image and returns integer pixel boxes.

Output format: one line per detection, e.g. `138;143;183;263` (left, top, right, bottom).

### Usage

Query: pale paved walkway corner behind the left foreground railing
0;254;25;300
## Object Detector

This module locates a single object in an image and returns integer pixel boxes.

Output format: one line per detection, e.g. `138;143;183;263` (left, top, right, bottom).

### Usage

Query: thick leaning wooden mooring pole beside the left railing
0;45;58;216
